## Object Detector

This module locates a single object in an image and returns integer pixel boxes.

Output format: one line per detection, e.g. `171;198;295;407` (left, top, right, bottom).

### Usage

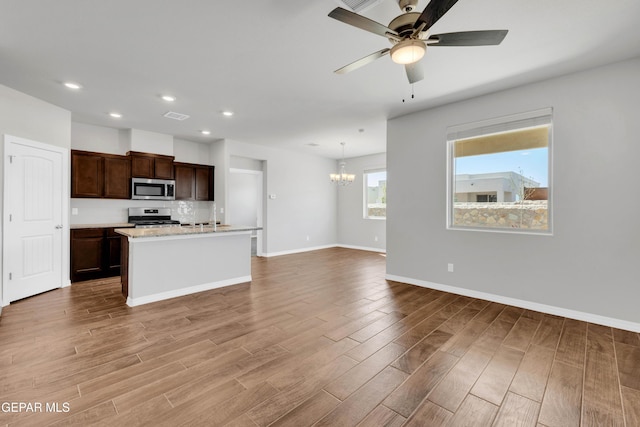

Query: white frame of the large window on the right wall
446;107;554;236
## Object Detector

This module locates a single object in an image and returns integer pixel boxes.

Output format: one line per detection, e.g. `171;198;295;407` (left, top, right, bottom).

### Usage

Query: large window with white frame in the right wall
447;108;552;234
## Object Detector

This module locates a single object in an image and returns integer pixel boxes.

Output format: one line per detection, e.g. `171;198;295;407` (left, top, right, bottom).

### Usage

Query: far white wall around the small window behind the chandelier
334;153;384;252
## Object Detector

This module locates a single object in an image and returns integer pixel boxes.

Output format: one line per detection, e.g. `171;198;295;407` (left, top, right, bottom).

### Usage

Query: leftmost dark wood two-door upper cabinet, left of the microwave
71;150;131;199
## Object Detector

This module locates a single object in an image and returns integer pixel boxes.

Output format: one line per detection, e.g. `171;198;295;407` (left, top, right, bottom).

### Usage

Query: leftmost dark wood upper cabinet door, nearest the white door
71;151;104;197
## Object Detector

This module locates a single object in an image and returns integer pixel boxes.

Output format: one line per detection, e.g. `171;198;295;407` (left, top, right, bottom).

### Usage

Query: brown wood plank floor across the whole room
0;248;640;427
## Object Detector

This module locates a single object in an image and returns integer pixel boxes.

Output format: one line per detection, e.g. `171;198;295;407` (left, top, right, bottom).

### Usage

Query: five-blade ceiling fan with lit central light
329;0;508;83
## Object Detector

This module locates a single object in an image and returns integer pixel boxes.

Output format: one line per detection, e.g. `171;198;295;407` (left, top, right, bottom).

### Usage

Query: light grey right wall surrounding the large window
387;59;640;329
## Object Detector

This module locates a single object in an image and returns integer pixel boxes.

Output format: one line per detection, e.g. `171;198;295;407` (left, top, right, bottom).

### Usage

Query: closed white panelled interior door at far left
3;136;64;303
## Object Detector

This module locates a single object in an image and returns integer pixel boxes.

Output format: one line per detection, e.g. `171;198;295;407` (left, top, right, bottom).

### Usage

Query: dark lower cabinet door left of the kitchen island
71;228;105;282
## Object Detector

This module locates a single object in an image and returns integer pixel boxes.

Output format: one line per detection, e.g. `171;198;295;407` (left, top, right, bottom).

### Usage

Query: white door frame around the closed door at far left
0;134;71;313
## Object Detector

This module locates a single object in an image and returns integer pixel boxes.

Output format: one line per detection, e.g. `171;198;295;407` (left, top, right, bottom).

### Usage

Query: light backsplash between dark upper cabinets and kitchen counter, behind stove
69;199;216;225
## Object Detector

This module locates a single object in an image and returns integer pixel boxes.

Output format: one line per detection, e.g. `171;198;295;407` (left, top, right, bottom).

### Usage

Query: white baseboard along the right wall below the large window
385;274;640;332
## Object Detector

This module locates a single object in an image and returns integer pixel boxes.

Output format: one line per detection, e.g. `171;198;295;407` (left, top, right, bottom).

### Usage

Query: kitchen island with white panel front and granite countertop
115;225;260;307
